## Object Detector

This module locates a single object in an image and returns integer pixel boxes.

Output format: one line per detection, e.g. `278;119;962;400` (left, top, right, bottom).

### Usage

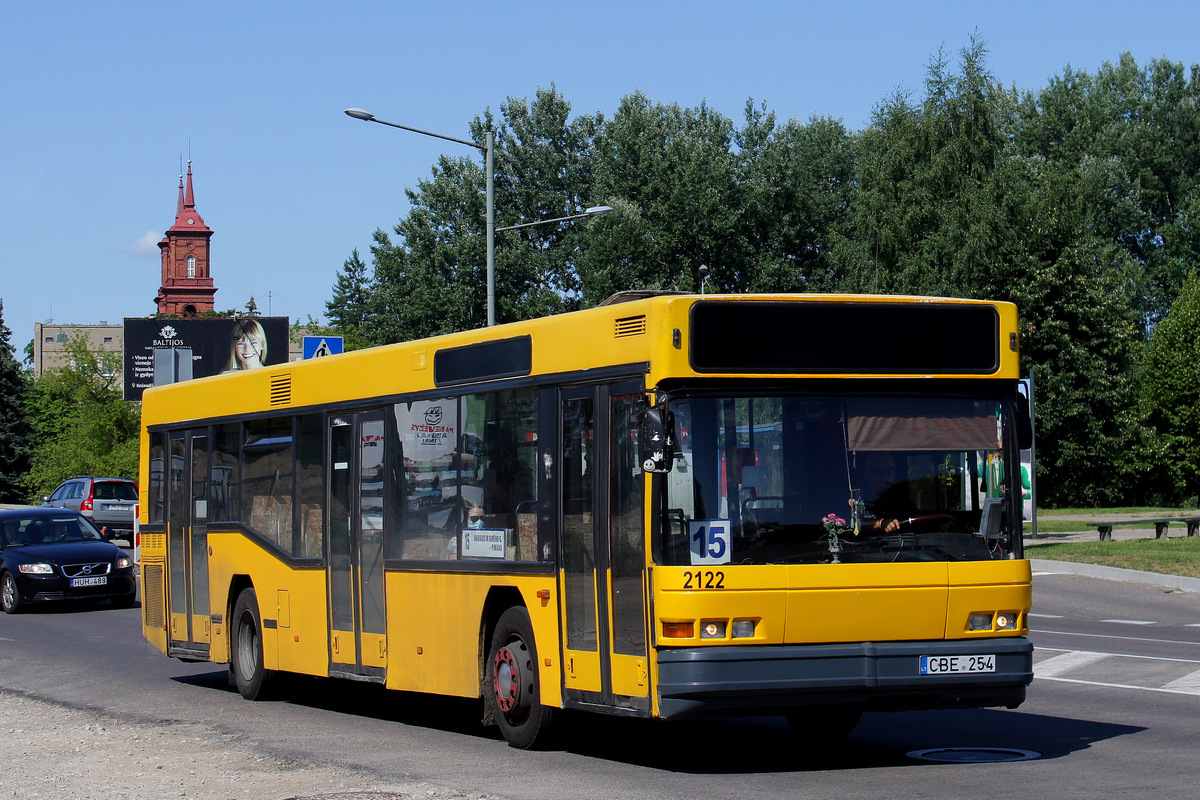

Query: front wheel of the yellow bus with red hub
484;606;554;750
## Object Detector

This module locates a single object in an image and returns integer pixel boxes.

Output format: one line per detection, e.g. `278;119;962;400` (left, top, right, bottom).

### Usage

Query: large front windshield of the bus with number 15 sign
659;395;1024;565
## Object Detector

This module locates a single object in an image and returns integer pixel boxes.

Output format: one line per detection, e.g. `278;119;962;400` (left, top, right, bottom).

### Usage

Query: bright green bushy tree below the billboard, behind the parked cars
24;337;140;498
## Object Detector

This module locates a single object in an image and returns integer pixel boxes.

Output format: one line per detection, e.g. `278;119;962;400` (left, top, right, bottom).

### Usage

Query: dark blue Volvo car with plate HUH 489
0;506;137;614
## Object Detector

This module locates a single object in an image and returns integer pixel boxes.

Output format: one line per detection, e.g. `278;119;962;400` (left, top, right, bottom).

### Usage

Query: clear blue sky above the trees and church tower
0;0;1200;354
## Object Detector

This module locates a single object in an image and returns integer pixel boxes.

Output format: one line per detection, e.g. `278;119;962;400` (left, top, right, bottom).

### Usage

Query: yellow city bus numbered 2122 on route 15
139;293;1032;747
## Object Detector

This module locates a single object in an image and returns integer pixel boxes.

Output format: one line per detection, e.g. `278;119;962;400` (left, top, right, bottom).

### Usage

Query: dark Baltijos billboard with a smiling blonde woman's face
125;317;288;401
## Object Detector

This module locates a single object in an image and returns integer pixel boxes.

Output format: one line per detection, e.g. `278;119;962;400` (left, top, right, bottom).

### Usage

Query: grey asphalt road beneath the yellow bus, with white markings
0;575;1200;800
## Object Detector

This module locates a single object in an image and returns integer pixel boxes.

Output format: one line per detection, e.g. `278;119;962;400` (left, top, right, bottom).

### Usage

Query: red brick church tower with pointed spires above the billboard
155;161;217;317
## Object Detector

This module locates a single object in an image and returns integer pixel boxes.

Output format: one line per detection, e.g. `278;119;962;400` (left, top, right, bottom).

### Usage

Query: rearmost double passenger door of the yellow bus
166;428;212;658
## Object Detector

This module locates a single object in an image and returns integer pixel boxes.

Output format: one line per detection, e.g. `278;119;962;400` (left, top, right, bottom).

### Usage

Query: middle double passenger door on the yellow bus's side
326;410;388;682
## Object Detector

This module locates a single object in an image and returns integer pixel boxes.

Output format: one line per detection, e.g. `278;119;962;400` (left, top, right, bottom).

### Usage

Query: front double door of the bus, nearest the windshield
558;381;649;711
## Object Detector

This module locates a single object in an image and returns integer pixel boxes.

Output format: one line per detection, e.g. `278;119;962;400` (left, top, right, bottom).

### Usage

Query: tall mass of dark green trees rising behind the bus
347;45;1200;505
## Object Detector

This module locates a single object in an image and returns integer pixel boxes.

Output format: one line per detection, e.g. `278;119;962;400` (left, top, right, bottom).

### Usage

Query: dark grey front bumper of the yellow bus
658;637;1033;718
